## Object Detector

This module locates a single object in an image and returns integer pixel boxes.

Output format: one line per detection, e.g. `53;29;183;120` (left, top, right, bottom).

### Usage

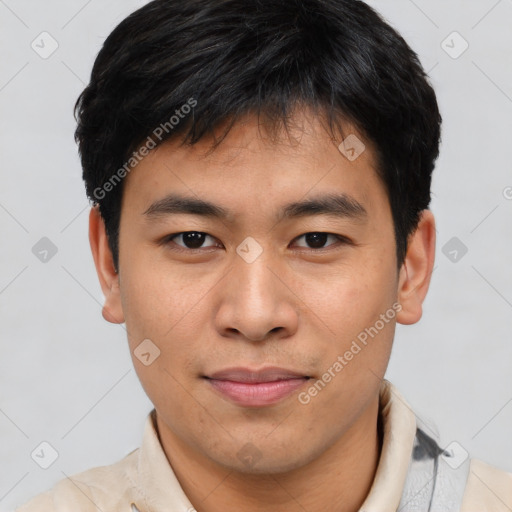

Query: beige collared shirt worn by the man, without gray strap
17;381;512;512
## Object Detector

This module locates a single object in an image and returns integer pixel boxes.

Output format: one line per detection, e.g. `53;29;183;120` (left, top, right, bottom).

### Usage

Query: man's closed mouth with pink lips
204;367;311;407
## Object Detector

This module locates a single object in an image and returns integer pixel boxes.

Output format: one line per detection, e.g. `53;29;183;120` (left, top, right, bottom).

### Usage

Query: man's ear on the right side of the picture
396;210;436;325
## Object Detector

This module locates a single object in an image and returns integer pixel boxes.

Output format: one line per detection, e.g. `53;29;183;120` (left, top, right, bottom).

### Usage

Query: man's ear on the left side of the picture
89;206;124;324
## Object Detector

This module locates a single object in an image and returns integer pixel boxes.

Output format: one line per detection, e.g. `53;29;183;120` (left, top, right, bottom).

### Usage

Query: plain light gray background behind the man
0;0;512;511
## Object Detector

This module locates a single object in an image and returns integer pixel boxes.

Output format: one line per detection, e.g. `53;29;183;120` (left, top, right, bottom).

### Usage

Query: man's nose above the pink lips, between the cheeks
215;246;299;342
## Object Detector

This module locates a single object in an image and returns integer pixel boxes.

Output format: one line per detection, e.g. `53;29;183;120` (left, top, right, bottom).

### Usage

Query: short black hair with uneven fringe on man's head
75;0;441;269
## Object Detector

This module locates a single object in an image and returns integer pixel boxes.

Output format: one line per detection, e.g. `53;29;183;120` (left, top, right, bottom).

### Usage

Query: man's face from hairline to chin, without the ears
93;110;432;473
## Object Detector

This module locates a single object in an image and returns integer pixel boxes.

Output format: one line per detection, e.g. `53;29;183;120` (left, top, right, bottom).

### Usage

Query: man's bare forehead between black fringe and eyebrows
119;111;385;218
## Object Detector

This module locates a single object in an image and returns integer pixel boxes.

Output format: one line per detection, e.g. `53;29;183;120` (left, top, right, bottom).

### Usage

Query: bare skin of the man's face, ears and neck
90;111;435;512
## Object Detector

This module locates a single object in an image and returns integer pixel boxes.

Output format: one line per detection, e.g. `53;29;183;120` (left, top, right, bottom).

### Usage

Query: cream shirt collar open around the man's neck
132;380;416;512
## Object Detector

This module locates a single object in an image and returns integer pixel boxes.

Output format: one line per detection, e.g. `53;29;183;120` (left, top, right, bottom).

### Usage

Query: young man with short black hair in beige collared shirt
19;0;512;512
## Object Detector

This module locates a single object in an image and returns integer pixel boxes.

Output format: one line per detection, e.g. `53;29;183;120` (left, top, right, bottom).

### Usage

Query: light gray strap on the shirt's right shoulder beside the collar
398;428;469;512
